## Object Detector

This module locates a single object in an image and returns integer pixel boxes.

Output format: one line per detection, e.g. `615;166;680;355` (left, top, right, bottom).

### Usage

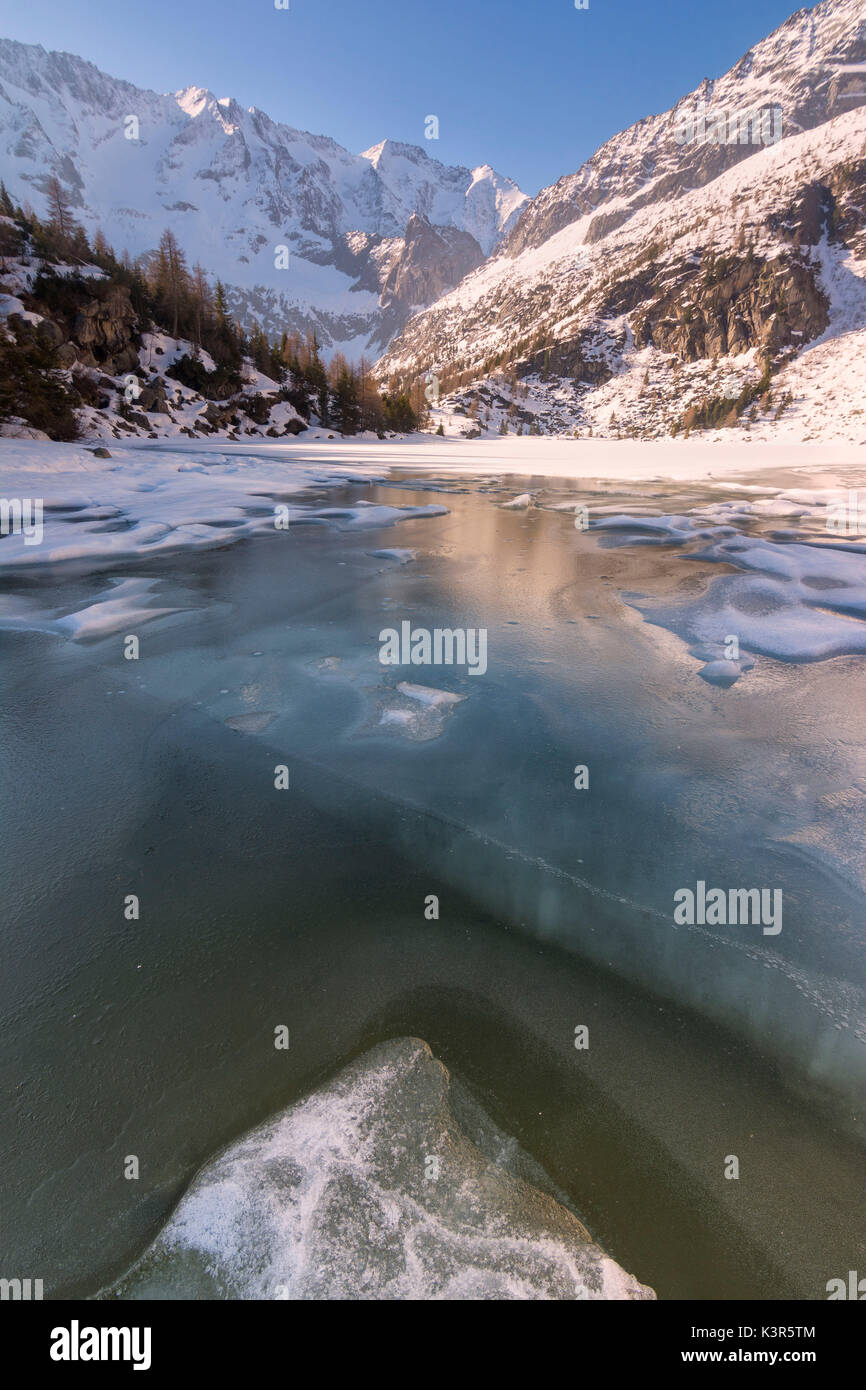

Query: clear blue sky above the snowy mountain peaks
0;0;798;193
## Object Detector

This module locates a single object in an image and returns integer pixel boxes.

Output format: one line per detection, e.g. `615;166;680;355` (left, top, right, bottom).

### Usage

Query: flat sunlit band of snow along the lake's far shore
0;435;866;524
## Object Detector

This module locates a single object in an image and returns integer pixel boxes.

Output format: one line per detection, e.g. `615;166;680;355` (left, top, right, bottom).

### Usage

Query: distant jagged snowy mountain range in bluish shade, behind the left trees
0;39;527;354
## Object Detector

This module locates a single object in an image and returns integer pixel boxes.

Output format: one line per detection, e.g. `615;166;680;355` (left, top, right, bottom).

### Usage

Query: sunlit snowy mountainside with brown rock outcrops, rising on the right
379;0;866;438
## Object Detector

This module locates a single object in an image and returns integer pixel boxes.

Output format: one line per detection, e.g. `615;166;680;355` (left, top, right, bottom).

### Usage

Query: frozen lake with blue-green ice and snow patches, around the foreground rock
0;445;866;1298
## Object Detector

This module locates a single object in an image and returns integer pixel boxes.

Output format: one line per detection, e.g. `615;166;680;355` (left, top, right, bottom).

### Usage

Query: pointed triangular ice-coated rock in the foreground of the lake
113;1038;655;1301
